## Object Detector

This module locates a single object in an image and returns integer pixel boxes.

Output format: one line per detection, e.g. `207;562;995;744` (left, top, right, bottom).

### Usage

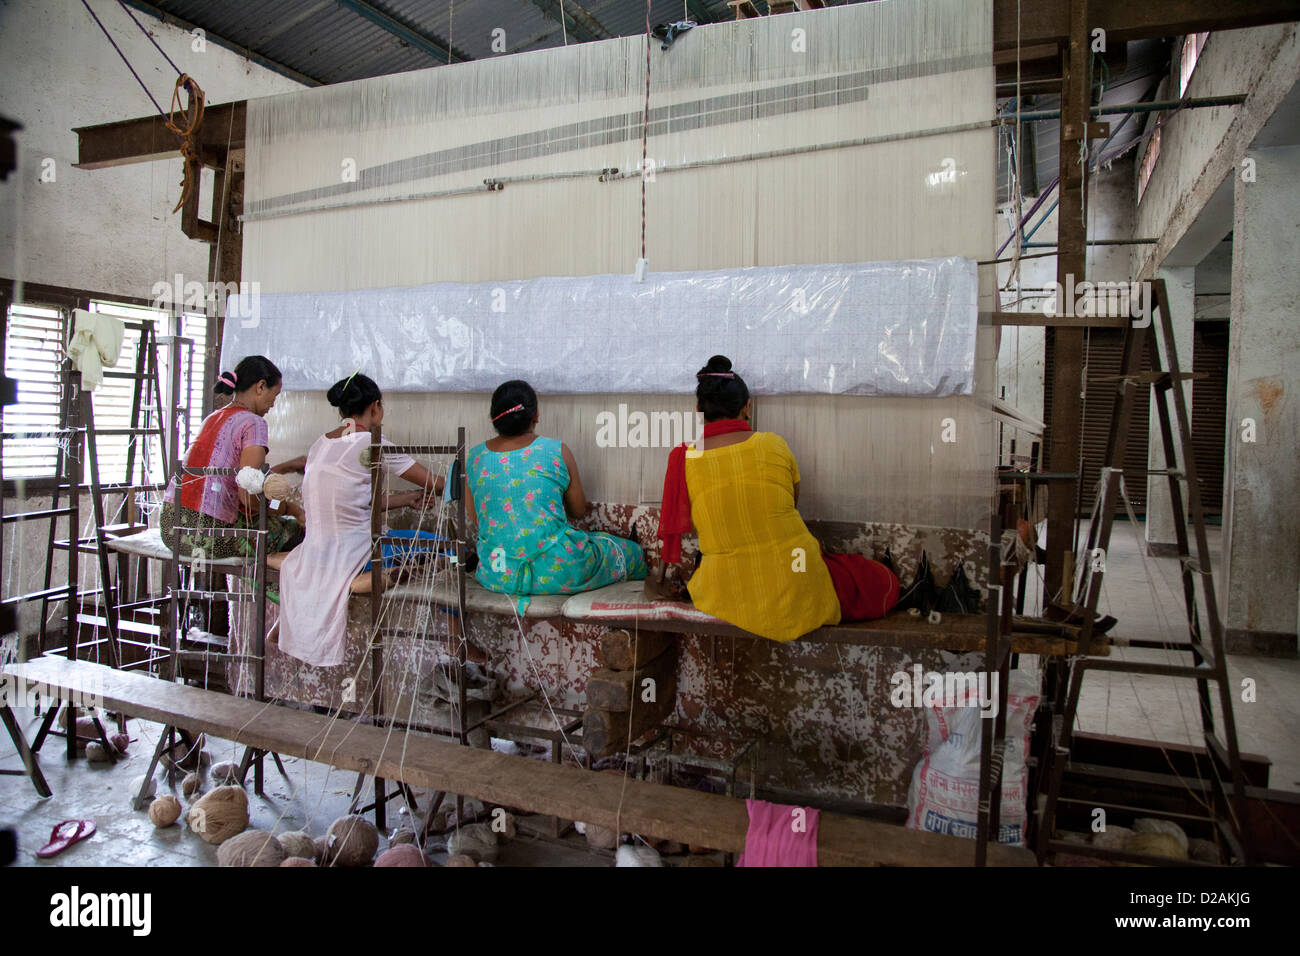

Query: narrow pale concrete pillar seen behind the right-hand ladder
1147;265;1196;555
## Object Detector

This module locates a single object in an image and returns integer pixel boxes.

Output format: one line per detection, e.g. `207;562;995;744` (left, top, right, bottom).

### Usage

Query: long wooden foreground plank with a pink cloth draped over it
0;657;1035;866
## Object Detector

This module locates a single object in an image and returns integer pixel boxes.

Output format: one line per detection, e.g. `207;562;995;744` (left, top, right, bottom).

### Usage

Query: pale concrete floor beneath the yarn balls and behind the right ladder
0;522;1300;866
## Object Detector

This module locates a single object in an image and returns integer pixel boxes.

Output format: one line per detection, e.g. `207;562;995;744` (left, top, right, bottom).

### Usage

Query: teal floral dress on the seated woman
467;438;646;610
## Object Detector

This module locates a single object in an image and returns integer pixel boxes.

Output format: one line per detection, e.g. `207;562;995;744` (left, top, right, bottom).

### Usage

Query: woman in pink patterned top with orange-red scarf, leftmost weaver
160;355;304;558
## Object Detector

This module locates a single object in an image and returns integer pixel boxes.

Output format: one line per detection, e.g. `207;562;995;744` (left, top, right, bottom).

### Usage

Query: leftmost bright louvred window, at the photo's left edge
0;303;66;481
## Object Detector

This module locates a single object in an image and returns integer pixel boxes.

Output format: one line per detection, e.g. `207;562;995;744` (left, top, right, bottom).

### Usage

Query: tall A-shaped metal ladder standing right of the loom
1036;280;1251;865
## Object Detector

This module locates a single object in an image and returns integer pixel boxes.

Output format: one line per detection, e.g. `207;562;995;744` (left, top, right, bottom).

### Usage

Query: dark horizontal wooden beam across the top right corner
993;0;1300;49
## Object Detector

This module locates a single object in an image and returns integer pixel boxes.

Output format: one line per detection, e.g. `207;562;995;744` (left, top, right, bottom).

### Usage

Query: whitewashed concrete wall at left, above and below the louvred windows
0;0;300;650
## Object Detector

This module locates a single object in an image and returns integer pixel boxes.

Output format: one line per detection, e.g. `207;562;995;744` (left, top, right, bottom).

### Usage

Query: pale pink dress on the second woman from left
280;432;415;667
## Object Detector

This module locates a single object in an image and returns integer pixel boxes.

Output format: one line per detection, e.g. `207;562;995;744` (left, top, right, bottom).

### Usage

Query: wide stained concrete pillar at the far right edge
1222;146;1300;657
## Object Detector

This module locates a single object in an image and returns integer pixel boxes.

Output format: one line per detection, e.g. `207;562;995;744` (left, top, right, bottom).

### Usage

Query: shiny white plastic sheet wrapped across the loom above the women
222;258;979;397
